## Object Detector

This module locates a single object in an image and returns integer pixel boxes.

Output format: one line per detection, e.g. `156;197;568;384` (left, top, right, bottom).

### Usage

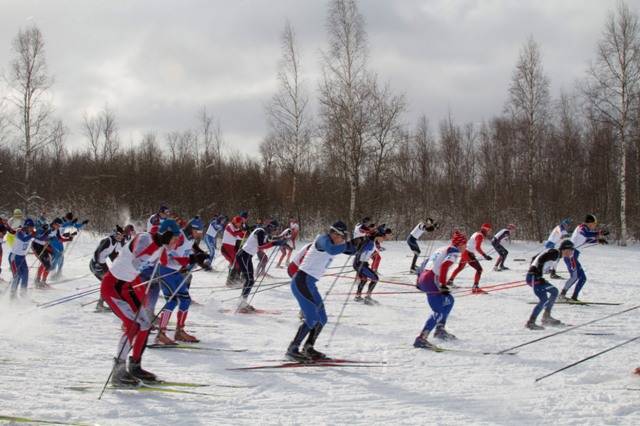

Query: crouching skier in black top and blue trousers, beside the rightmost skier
525;240;574;330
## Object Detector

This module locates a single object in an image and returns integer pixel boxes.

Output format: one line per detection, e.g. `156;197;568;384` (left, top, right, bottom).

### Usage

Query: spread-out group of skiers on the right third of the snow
407;214;608;349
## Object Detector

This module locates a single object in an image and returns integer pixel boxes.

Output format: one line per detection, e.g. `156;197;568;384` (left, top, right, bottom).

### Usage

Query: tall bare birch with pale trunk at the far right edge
585;1;640;245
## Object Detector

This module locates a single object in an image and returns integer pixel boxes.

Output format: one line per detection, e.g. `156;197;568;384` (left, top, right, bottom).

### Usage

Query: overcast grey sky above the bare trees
0;0;640;155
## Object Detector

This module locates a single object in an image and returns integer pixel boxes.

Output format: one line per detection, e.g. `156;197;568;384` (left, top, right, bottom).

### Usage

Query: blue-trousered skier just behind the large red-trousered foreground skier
155;216;209;345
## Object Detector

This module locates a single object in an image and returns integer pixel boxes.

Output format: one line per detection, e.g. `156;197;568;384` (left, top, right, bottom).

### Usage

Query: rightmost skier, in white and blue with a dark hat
560;214;609;302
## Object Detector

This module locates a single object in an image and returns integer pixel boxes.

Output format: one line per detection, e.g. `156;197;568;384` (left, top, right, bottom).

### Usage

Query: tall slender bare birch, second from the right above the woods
507;37;551;239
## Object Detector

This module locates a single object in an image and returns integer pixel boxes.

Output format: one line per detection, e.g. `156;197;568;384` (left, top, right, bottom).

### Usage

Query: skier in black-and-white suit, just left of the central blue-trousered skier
236;220;285;314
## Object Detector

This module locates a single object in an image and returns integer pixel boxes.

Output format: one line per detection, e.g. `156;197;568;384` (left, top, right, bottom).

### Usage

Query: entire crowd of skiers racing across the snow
0;205;606;385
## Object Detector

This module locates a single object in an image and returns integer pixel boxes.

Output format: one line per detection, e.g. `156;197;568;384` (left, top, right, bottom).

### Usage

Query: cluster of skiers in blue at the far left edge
0;209;89;298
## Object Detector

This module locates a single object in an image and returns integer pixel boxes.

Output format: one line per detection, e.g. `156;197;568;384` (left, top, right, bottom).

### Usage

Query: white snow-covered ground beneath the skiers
0;234;640;425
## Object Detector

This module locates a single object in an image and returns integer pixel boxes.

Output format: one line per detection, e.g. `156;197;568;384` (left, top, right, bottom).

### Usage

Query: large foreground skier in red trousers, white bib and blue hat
100;219;180;386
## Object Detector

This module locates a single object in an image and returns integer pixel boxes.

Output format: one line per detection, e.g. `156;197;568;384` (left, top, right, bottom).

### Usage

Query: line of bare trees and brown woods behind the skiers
0;0;640;244
